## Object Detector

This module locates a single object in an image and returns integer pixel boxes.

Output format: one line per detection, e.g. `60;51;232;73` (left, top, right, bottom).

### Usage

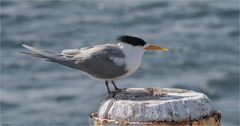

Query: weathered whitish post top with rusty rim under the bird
91;88;221;126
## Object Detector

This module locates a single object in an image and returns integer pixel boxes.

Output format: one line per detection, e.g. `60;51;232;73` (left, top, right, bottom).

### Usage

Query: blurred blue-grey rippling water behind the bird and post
0;0;239;126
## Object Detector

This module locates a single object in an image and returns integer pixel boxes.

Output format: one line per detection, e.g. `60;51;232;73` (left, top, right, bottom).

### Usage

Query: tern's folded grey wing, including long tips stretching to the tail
21;45;127;79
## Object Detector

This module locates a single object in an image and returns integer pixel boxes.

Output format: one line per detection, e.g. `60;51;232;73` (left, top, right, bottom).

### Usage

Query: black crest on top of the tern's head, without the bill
117;35;146;46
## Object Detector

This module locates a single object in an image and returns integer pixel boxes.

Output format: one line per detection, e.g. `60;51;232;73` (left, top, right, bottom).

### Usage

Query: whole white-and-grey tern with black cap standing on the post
21;35;168;93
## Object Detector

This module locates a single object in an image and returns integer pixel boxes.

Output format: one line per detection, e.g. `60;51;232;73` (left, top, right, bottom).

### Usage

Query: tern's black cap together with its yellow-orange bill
117;35;168;51
